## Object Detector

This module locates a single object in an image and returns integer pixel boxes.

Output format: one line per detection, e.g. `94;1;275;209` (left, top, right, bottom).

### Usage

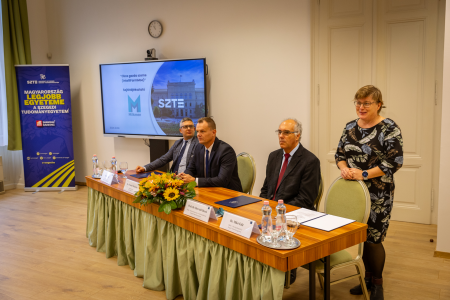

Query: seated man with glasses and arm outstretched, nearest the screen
136;118;198;173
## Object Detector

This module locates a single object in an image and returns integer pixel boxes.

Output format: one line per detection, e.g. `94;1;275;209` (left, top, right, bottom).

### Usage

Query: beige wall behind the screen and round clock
28;0;311;194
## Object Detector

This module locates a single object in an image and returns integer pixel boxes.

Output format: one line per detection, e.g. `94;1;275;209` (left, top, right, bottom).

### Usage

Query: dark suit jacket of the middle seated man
185;137;242;192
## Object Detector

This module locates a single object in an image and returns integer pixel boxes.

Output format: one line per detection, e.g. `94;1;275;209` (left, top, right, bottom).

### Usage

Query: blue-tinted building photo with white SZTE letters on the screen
149;60;205;136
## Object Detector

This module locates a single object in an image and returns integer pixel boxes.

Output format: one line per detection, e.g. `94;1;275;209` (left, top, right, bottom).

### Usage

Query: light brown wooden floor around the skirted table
0;187;450;300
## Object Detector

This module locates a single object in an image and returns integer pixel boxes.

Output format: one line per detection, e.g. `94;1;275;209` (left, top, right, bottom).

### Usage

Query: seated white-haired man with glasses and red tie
259;119;320;209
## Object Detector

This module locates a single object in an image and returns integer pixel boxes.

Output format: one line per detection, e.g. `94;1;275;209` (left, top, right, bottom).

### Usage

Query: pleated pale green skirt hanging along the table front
86;188;284;300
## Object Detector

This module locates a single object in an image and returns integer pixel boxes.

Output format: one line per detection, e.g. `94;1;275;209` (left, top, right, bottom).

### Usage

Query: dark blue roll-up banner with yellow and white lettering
16;65;77;191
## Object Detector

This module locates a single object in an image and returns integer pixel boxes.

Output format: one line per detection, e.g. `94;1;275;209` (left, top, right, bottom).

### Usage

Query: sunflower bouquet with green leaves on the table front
133;173;196;214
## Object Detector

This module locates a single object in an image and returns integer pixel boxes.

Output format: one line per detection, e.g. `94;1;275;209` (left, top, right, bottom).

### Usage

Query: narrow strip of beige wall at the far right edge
436;0;450;253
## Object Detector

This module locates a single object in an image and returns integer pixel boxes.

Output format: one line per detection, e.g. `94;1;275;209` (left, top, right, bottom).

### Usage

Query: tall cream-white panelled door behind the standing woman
315;0;438;224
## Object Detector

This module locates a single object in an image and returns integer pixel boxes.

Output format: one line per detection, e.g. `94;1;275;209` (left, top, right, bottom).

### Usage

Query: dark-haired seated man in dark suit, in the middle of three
180;117;242;192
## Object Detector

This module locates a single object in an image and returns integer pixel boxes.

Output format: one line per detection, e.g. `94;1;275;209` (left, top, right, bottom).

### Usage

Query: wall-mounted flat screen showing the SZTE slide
100;58;207;139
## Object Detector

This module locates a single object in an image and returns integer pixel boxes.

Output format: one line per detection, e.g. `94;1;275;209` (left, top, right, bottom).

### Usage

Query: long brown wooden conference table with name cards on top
86;171;367;299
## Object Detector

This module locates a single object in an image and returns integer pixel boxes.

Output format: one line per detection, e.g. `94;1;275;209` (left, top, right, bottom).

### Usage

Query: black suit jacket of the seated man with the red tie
259;144;320;210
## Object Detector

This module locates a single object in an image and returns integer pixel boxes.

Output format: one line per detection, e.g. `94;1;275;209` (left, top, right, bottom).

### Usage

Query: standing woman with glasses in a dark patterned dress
335;85;403;300
